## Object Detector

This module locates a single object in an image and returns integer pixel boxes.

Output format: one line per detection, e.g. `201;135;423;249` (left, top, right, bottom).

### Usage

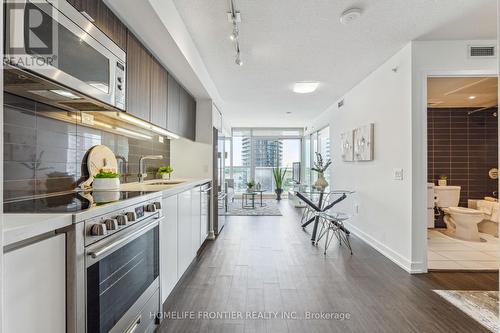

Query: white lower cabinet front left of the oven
3;234;66;333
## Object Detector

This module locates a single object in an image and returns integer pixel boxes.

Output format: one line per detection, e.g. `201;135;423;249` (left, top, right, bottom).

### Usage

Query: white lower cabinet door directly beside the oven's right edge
160;195;179;303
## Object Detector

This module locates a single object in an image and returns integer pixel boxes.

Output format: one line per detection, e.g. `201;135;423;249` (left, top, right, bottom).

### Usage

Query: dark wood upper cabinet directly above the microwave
68;0;127;50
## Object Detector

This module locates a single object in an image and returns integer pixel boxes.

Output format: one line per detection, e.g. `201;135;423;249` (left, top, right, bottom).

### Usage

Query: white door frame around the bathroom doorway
412;69;500;273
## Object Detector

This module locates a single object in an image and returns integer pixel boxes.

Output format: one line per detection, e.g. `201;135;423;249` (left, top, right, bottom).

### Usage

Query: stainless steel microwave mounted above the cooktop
4;0;126;111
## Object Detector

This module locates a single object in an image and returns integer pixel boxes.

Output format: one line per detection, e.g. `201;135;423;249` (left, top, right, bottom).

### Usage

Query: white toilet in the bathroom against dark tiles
434;186;484;242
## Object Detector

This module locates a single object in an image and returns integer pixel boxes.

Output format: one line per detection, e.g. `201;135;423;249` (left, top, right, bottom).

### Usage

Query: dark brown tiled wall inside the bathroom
427;108;498;207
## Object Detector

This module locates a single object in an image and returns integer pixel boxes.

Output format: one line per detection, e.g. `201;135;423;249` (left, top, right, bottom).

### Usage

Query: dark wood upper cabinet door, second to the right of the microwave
150;59;168;128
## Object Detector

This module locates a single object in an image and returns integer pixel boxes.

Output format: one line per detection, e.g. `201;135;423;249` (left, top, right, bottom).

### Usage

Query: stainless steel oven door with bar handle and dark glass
86;216;160;333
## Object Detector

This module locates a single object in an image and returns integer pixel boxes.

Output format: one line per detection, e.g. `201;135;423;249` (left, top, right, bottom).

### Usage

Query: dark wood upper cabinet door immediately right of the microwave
127;32;153;121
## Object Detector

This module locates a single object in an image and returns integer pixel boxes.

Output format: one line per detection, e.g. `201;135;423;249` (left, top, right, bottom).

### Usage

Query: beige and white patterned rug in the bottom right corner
434;290;499;333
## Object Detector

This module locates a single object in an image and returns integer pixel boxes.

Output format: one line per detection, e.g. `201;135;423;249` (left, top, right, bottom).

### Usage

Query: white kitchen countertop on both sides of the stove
3;178;212;246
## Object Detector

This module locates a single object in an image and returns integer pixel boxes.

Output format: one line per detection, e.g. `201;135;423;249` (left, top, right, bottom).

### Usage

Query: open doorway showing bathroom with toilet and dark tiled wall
427;76;499;271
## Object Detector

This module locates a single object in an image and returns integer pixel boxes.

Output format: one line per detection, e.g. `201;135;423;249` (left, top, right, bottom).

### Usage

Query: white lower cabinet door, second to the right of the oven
177;190;195;278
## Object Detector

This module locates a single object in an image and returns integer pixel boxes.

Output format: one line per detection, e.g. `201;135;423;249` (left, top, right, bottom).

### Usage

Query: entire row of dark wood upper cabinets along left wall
67;0;196;140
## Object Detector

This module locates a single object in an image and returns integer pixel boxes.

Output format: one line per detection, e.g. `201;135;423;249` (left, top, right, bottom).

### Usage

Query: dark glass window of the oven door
87;226;159;332
